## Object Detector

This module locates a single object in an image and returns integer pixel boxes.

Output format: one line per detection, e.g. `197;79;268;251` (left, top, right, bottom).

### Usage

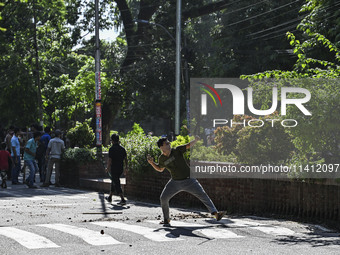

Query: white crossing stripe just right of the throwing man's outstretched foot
220;219;295;236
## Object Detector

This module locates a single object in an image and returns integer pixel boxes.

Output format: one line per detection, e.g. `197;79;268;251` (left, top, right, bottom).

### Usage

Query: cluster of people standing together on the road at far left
0;126;65;188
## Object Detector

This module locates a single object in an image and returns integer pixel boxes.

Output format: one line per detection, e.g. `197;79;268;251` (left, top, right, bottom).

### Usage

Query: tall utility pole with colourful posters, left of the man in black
95;0;103;155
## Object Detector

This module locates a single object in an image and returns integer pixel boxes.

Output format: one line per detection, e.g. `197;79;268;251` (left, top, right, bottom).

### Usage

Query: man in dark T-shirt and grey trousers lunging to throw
147;137;226;225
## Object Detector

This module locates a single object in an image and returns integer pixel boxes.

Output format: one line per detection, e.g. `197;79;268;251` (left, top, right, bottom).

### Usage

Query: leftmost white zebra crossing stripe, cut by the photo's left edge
0;227;60;249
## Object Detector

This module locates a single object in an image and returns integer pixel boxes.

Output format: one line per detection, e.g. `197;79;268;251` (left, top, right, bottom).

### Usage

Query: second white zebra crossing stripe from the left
37;224;121;245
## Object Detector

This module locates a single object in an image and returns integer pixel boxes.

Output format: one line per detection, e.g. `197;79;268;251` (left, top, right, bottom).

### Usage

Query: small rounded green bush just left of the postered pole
67;122;95;148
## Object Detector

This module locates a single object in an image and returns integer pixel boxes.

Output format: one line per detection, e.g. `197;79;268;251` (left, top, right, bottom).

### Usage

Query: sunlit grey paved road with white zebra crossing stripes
0;182;340;255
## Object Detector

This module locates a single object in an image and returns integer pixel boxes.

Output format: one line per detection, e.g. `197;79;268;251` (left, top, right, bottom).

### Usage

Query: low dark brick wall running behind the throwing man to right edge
125;171;340;223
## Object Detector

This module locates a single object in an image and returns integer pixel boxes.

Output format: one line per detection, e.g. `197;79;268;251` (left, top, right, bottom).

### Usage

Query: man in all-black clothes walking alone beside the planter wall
106;134;128;205
